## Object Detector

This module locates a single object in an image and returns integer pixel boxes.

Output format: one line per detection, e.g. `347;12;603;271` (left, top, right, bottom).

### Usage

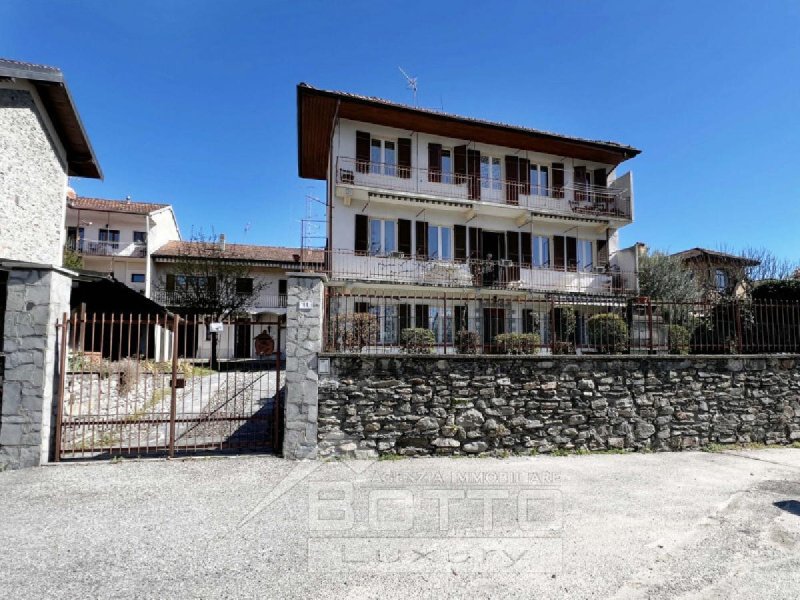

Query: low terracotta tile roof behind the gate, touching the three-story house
153;241;323;264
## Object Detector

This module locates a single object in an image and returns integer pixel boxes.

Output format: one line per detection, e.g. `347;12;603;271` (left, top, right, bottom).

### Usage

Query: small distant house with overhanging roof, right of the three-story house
672;248;759;297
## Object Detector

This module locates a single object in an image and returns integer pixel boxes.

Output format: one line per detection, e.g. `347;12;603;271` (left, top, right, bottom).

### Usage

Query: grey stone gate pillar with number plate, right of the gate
283;273;327;460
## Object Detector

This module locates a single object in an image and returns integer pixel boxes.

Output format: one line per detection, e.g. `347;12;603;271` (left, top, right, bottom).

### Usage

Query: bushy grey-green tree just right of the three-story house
639;252;700;302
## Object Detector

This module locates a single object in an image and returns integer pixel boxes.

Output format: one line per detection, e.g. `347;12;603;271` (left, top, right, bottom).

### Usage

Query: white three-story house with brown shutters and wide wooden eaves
297;84;640;344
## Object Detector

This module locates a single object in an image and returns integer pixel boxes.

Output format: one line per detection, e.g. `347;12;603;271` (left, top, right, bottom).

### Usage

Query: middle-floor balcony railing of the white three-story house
326;250;636;294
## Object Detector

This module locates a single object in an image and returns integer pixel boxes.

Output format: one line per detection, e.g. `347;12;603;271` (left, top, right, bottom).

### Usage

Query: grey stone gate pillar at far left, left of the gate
0;269;72;470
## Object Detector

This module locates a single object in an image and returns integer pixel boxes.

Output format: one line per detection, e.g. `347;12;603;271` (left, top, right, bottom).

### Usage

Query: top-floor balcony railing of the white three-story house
336;157;633;220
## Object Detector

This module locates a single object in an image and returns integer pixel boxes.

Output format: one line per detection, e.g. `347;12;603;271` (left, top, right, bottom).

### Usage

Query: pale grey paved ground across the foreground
0;449;800;599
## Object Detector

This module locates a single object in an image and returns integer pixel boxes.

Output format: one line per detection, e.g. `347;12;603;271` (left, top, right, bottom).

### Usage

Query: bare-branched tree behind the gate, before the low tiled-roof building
157;231;267;368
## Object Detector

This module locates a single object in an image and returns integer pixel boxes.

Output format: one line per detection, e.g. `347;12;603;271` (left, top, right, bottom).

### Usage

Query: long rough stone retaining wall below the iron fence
318;354;800;456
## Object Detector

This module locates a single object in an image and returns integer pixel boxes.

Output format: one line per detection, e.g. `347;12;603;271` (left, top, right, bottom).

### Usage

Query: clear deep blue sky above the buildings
0;0;800;259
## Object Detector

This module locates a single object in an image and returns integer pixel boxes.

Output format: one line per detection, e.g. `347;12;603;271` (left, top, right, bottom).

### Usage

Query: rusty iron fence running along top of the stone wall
325;288;800;354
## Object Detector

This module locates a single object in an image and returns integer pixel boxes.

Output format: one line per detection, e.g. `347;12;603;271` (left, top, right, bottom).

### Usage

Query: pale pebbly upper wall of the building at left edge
0;82;67;265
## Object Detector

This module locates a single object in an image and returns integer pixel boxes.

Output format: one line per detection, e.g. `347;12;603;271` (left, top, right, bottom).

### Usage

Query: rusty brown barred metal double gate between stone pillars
54;313;285;460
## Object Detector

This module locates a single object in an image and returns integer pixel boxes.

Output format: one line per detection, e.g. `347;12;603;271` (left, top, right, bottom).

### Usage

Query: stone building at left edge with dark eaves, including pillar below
0;59;101;470
